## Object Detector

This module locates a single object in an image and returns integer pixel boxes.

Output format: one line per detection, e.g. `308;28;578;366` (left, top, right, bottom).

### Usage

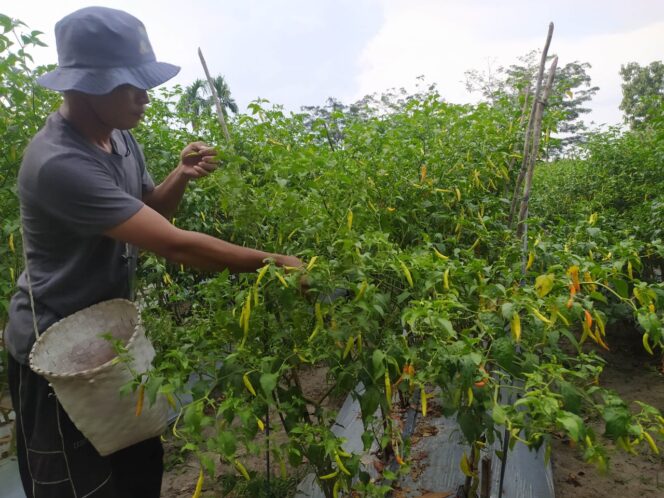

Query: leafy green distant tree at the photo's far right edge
620;61;664;128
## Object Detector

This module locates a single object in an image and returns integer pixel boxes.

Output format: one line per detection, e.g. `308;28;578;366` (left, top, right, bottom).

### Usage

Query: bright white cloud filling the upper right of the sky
354;0;664;123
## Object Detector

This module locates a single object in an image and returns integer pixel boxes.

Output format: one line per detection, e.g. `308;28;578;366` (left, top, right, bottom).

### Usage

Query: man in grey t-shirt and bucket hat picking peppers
5;7;301;498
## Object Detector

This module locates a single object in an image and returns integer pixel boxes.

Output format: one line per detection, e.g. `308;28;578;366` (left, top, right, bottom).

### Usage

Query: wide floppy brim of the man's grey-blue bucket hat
37;62;180;95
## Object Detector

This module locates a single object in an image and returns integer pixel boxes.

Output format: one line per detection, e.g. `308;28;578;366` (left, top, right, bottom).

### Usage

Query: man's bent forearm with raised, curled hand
143;142;217;219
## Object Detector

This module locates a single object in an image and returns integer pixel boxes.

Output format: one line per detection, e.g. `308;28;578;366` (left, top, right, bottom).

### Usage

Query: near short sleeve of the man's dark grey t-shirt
35;154;144;235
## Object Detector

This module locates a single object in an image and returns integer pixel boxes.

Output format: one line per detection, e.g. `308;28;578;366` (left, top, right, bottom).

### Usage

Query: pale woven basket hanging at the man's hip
30;299;168;456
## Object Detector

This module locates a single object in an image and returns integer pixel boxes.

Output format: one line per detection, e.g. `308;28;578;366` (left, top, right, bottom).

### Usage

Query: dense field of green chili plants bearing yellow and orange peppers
0;11;664;498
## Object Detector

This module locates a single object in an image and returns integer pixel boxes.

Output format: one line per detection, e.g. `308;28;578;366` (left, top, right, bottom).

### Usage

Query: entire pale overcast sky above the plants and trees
5;0;664;124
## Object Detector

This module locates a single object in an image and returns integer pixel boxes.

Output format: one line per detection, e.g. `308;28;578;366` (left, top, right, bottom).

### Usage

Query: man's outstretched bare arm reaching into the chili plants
104;206;302;273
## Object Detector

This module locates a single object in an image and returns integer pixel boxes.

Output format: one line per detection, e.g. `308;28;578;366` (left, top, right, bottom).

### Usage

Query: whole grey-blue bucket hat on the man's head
37;7;180;95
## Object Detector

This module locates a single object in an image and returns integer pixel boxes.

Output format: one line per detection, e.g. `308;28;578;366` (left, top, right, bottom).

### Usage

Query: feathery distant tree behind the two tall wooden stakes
465;51;599;153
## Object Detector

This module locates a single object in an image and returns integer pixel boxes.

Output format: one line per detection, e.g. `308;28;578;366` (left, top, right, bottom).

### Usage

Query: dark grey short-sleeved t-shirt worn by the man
4;112;154;363
